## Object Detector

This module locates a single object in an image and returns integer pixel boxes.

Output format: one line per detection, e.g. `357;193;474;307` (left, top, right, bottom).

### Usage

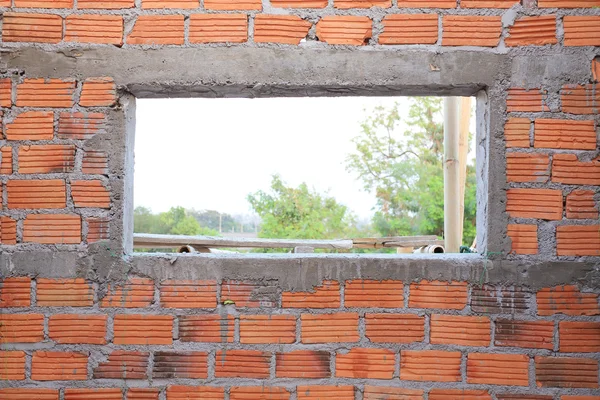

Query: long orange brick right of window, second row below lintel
534;119;597;150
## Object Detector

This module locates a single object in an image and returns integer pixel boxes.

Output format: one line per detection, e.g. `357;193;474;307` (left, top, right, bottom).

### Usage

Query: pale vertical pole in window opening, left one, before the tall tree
444;97;460;253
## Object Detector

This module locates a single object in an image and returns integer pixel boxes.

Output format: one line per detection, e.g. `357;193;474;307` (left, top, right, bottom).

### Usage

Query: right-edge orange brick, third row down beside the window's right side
552;154;600;185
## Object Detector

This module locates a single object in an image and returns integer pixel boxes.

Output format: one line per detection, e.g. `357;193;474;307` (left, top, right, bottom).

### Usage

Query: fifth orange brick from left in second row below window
240;315;296;344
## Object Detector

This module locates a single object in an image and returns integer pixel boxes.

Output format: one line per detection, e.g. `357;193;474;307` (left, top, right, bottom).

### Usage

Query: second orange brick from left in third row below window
31;351;88;381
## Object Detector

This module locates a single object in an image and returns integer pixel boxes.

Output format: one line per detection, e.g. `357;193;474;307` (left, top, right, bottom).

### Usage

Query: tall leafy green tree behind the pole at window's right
346;97;476;244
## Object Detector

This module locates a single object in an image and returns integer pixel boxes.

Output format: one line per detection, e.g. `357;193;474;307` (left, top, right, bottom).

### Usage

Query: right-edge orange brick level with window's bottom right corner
556;225;600;256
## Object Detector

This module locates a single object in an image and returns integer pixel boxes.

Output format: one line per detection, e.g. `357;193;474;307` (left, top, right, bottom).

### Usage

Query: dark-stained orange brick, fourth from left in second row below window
179;314;234;343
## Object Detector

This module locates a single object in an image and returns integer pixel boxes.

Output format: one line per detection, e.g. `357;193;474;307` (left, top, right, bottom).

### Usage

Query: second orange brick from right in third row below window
467;353;529;386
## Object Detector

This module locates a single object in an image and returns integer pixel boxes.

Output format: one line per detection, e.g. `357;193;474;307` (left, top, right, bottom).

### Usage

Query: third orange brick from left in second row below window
113;314;173;345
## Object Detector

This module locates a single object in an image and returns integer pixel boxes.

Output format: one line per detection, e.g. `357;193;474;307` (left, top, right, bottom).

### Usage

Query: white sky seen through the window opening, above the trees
134;97;476;219
